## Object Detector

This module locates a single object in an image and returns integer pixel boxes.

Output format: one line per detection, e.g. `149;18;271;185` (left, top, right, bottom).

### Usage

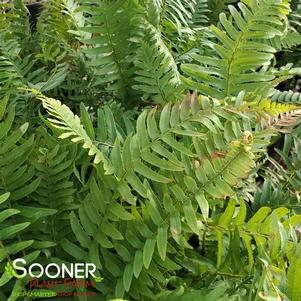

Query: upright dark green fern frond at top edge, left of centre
83;0;138;100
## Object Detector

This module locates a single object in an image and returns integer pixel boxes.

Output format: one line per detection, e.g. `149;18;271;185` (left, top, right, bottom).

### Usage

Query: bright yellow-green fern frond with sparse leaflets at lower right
215;201;300;269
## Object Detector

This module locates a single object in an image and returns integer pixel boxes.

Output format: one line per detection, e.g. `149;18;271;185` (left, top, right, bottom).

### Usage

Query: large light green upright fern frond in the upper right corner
182;0;289;98
